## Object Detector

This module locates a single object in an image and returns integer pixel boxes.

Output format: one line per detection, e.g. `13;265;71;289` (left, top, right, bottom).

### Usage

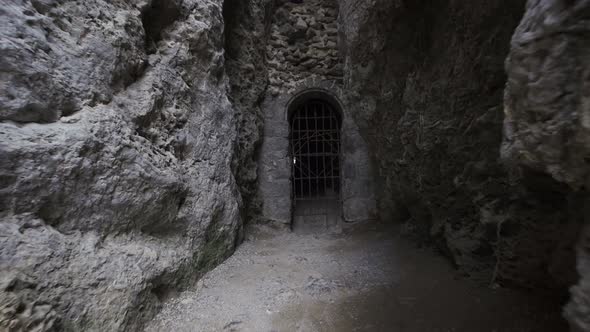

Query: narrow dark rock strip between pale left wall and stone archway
223;0;273;226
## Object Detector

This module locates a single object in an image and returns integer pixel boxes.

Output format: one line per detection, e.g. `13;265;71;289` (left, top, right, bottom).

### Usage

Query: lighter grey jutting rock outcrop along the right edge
502;0;590;332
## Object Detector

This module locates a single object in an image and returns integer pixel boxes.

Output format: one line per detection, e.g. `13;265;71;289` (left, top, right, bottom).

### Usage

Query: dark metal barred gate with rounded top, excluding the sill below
291;99;340;204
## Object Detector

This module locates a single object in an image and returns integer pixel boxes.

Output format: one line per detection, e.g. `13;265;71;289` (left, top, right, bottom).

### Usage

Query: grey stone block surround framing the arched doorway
258;79;376;227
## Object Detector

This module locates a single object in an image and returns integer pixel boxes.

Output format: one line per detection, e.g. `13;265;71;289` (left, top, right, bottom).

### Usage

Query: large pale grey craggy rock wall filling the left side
0;0;247;331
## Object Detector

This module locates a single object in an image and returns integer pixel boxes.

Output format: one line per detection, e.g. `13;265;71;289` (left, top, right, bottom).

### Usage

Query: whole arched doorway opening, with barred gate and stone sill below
289;96;341;230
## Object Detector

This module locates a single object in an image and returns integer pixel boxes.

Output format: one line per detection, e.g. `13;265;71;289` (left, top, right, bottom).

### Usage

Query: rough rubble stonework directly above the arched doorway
266;0;343;96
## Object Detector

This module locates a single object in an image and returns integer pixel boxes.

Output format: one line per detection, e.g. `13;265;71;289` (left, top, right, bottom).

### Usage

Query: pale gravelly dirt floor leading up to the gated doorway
146;223;567;332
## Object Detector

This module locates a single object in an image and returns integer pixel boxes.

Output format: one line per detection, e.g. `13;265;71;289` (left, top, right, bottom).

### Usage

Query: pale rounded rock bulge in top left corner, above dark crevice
0;1;147;122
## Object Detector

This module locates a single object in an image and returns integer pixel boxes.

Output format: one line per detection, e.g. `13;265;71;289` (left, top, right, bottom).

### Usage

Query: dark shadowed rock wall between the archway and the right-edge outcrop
339;0;579;292
